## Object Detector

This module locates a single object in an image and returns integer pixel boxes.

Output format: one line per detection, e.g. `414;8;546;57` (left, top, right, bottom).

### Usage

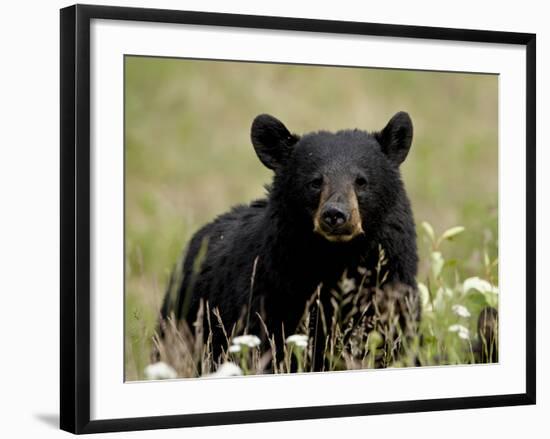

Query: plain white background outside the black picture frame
0;0;550;439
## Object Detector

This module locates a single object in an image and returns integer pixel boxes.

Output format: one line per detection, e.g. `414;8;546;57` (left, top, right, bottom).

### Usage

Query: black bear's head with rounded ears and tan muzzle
251;112;413;242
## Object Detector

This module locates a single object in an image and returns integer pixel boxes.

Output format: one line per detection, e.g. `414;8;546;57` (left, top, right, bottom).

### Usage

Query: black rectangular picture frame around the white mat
60;5;536;434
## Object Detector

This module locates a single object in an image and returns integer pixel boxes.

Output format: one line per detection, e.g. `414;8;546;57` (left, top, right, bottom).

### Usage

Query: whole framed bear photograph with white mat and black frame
61;5;536;433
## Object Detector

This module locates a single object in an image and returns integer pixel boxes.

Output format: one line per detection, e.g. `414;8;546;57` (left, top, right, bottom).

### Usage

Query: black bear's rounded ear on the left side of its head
250;114;298;170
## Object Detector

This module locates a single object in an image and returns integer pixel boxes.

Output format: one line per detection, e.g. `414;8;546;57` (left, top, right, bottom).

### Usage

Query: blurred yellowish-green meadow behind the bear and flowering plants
125;56;498;380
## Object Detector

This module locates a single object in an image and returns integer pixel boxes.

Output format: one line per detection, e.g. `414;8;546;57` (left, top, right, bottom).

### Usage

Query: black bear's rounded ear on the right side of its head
375;111;413;165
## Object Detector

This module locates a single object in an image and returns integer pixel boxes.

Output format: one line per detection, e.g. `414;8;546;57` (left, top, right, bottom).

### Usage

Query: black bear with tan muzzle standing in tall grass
161;112;419;370
